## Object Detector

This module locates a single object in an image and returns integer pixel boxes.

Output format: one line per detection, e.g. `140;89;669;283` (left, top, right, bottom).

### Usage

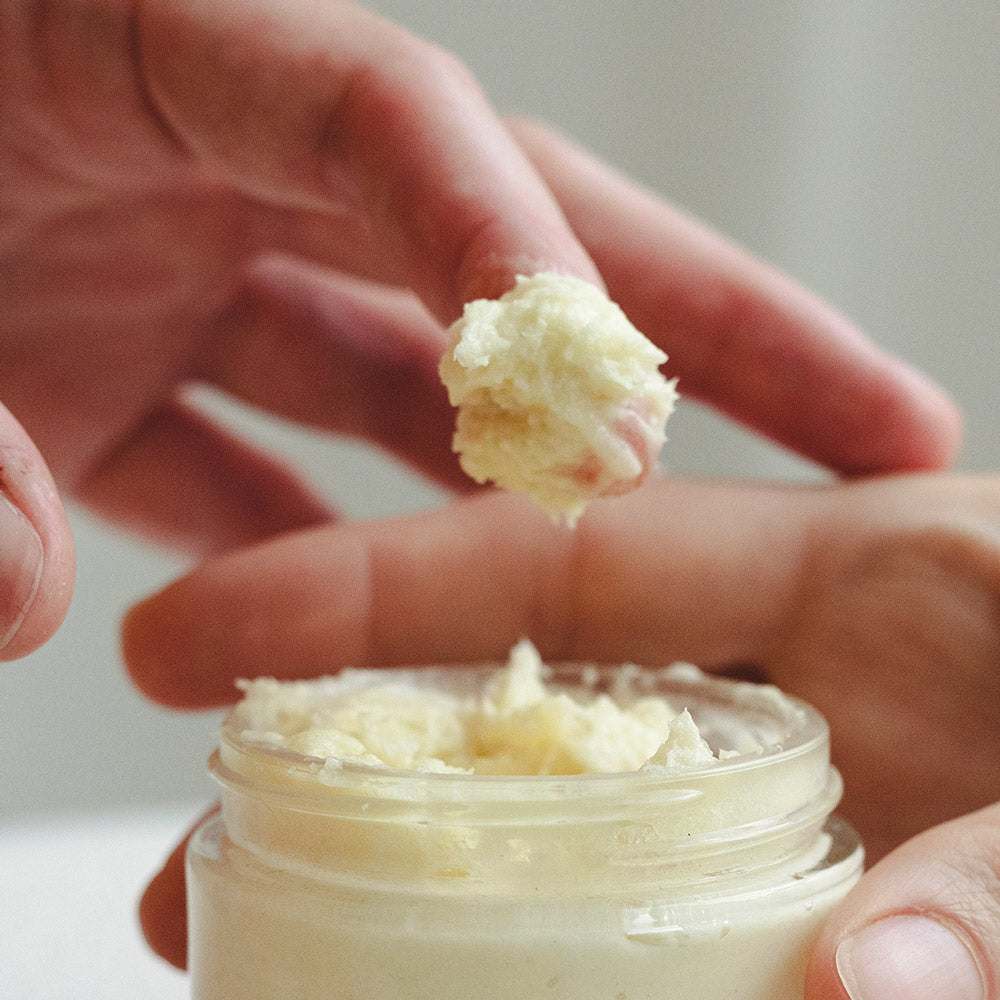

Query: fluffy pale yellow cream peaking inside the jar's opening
234;641;728;775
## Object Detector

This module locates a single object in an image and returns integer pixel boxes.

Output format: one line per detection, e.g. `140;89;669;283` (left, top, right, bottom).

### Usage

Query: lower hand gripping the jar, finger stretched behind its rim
124;475;1000;1000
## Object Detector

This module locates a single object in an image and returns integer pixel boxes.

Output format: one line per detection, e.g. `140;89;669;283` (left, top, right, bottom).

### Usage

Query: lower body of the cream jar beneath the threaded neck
189;876;853;1000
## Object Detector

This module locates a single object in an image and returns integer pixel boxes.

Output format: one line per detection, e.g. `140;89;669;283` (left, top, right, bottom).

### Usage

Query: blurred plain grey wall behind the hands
0;0;1000;821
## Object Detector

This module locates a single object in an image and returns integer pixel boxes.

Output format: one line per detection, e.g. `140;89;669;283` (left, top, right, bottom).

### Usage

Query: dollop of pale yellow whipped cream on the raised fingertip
440;273;677;526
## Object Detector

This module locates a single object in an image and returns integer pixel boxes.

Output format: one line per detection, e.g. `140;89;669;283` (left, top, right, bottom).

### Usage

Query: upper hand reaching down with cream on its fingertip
0;0;958;658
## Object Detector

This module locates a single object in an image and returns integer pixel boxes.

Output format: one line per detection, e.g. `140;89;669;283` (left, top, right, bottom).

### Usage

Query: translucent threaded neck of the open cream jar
211;726;841;895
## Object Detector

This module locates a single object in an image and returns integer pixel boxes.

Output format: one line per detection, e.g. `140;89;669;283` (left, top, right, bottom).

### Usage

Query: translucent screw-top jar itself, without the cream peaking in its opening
188;666;862;1000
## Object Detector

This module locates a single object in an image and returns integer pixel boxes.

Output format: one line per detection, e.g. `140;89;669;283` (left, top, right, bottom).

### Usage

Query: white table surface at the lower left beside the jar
0;804;203;1000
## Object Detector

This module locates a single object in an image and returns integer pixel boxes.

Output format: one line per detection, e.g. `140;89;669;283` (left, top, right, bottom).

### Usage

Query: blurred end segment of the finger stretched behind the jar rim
121;525;368;710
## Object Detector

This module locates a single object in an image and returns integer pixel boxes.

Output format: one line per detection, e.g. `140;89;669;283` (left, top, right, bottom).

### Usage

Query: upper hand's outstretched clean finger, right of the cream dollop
511;122;961;474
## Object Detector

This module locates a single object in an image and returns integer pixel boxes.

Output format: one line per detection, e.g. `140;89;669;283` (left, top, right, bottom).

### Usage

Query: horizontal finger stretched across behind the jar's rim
123;481;822;707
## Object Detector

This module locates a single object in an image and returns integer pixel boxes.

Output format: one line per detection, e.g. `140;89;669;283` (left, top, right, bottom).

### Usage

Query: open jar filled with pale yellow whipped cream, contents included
188;642;862;1000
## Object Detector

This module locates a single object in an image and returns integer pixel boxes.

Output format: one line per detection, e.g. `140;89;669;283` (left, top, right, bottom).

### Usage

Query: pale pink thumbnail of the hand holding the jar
836;914;986;1000
